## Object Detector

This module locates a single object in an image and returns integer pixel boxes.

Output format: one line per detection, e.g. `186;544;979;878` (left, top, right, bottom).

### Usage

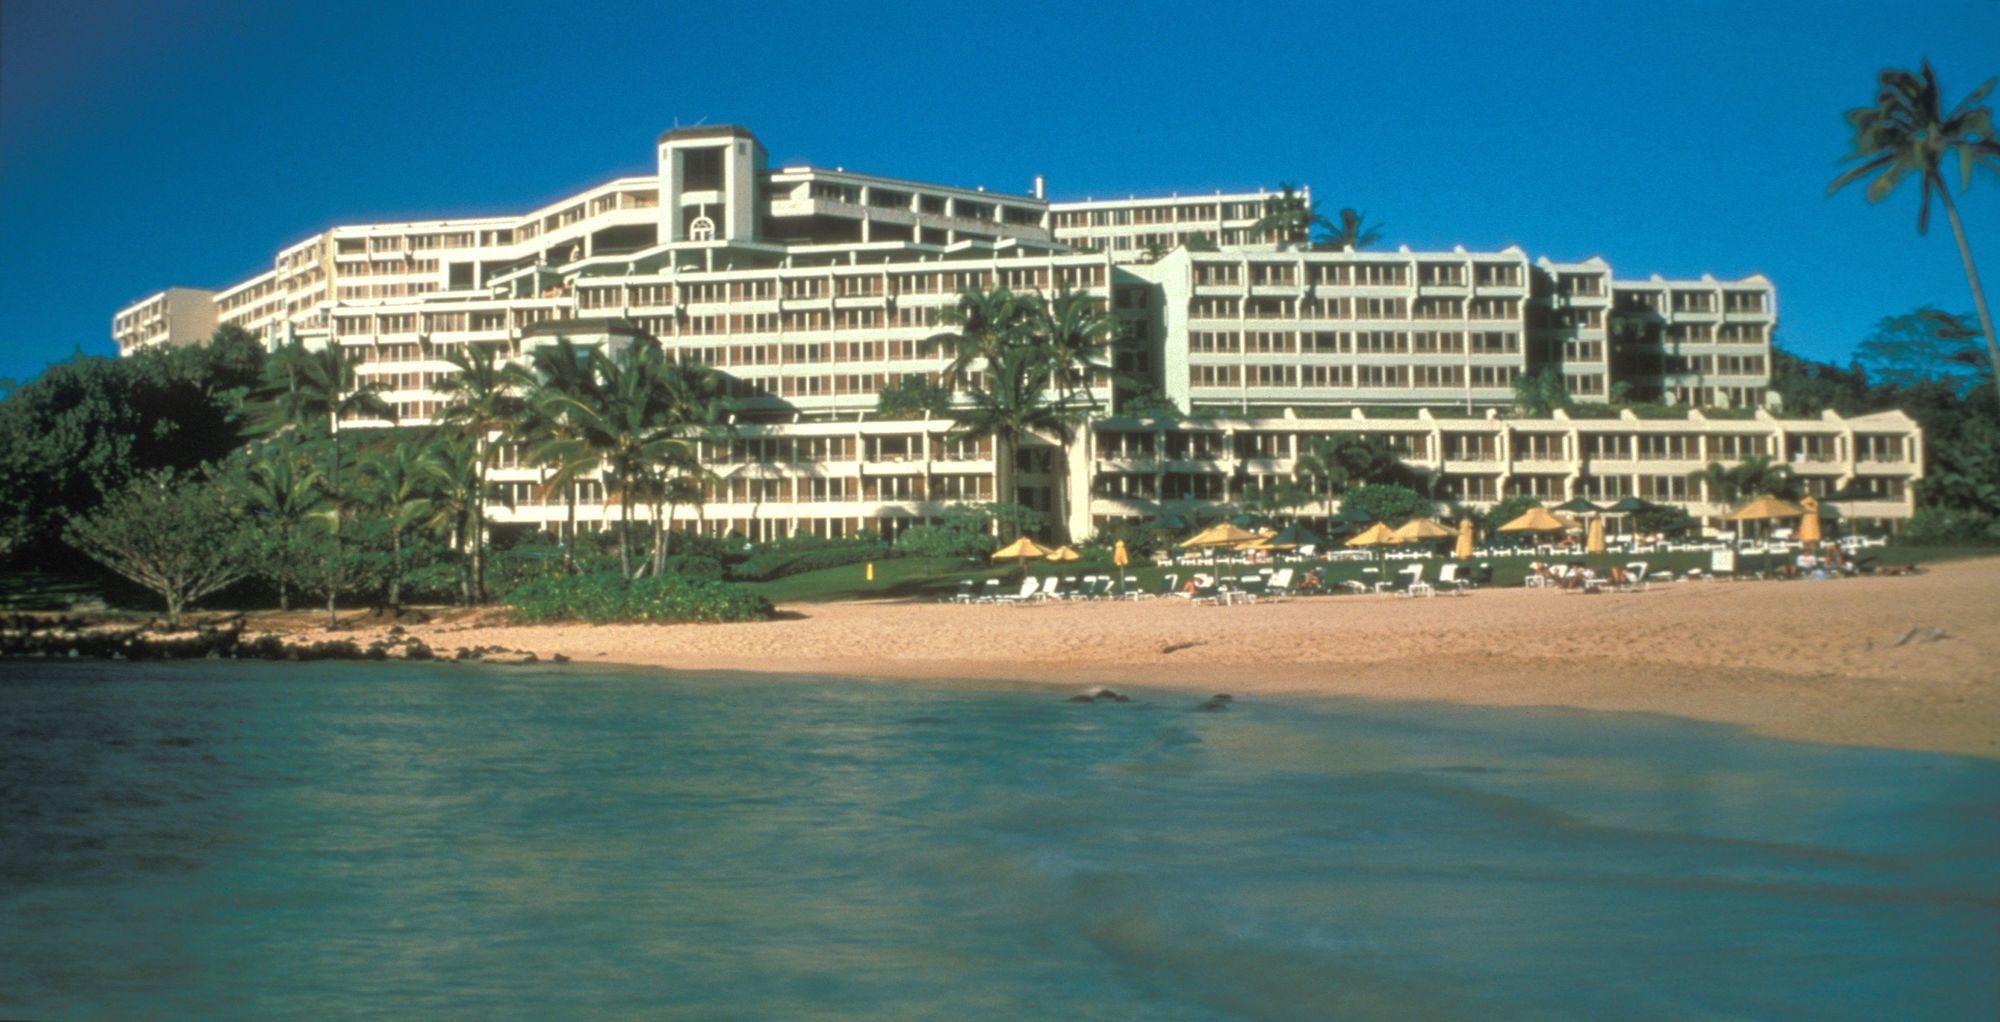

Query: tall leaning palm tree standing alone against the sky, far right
1826;60;2000;388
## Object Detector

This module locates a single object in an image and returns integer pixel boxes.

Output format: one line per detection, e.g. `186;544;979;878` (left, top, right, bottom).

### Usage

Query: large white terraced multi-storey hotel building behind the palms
112;126;1922;538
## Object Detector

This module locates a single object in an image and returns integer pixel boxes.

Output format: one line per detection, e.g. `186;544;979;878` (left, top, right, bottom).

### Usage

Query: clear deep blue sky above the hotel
0;0;2000;378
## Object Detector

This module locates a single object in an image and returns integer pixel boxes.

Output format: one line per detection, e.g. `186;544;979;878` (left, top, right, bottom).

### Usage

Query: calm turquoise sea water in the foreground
0;662;2000;1020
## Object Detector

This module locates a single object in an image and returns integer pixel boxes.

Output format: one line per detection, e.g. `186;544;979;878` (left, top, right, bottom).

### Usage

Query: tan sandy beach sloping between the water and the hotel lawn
356;558;2000;758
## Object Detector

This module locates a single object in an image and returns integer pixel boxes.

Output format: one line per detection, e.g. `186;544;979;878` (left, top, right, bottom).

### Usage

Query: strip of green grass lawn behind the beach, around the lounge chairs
750;546;2000;604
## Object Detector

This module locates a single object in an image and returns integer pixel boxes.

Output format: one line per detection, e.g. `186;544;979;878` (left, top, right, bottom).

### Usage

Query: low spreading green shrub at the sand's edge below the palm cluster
512;574;774;624
